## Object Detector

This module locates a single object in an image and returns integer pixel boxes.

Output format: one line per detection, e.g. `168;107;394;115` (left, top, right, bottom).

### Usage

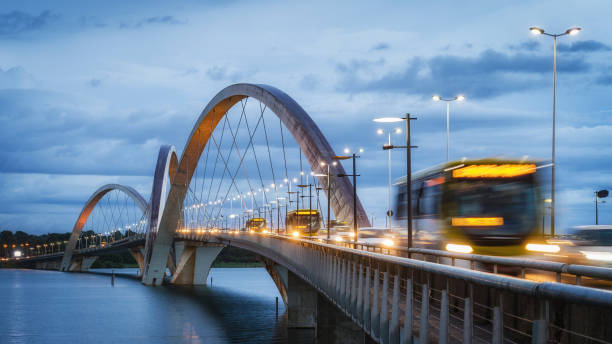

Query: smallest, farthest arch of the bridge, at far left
60;184;148;271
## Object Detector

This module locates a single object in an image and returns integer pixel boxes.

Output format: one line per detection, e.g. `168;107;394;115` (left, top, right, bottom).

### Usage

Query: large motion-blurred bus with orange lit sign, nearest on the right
395;159;546;255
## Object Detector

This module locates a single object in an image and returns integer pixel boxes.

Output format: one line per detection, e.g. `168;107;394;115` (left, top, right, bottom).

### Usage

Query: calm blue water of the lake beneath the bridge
0;268;287;344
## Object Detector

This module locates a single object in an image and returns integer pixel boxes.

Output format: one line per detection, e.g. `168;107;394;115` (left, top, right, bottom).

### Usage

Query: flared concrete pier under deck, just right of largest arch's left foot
170;241;224;285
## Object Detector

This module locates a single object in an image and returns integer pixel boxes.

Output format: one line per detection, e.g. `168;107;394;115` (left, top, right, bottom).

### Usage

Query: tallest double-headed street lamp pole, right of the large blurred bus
529;26;581;235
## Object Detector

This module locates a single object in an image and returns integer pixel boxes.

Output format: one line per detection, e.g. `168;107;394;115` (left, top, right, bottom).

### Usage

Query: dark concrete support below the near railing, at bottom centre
287;272;374;344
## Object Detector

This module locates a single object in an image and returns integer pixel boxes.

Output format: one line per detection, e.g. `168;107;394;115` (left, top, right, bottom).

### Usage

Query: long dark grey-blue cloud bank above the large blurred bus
336;49;590;98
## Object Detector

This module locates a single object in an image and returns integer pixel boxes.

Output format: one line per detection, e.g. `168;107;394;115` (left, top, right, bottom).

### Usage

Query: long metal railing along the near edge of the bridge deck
201;231;612;343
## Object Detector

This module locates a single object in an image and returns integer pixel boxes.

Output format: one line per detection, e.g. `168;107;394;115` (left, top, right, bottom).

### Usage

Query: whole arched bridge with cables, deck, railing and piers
4;84;612;343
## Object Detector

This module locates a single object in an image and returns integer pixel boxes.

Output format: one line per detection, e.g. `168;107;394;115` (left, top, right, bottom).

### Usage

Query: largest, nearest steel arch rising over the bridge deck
143;84;370;284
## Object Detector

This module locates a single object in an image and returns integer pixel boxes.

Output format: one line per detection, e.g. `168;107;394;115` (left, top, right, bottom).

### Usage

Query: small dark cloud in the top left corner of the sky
0;10;58;37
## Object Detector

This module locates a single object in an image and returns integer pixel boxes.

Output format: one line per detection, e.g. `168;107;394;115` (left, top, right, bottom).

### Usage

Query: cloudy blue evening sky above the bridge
0;0;612;233
